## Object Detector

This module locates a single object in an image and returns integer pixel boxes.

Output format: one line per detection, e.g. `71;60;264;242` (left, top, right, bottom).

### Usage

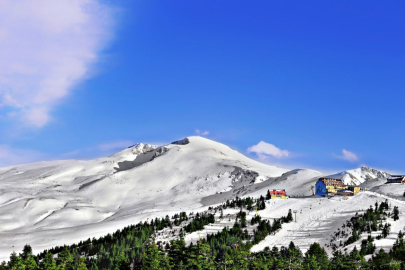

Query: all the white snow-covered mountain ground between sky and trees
0;137;405;261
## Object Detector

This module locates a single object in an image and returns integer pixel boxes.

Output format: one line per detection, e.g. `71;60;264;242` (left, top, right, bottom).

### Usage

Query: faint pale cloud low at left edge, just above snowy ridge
0;144;45;167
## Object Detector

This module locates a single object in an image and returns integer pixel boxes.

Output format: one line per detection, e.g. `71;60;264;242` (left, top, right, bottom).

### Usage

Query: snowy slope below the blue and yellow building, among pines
251;192;405;255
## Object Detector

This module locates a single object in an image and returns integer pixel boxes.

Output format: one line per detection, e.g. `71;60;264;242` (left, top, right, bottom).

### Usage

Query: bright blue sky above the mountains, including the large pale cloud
0;0;405;173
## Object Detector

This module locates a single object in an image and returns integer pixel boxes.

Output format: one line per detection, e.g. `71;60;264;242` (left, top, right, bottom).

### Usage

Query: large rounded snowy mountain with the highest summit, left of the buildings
0;137;287;260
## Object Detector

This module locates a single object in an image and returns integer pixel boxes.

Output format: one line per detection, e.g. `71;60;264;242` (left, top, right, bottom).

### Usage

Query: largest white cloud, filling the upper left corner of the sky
0;0;114;127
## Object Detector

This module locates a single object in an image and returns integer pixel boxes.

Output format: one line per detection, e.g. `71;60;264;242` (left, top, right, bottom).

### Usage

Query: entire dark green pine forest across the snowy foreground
0;193;405;270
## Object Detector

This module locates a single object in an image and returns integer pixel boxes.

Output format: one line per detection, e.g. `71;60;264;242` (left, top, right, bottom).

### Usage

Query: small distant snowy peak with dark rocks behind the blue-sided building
328;166;390;185
